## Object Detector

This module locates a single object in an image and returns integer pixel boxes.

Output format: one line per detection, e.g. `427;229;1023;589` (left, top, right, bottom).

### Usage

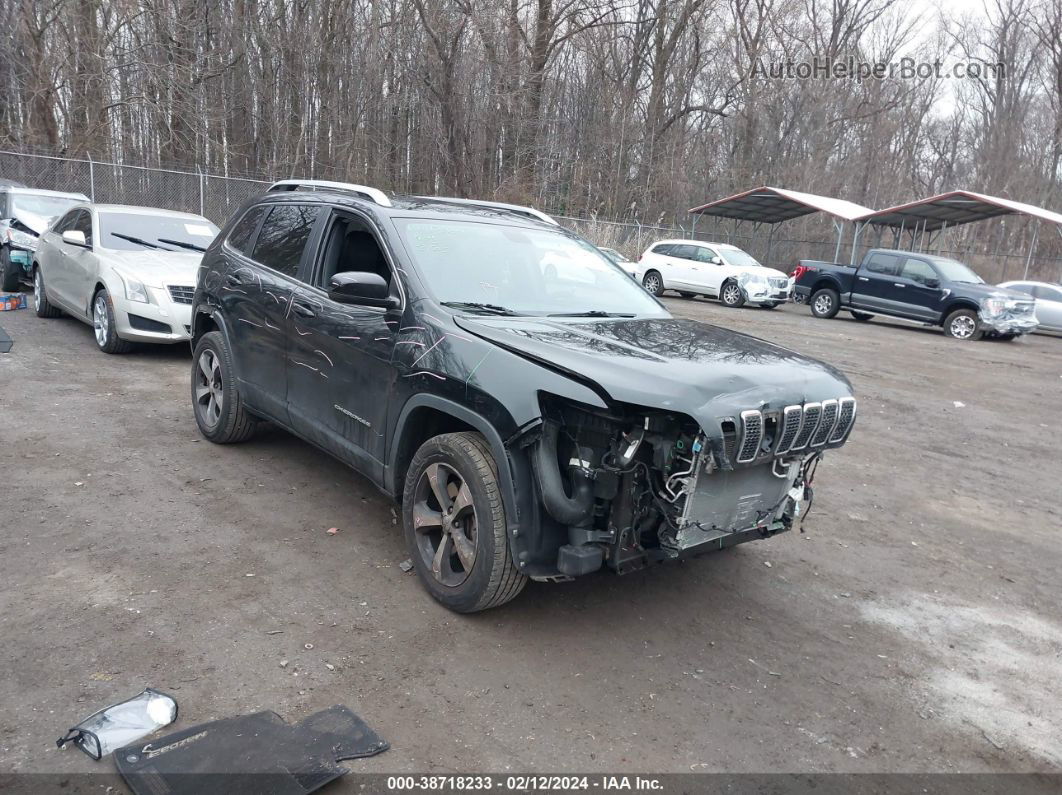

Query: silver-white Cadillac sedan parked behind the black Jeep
33;204;218;353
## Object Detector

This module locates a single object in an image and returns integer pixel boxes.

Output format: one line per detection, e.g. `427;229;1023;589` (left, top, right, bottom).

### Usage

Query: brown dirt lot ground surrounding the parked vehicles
0;292;1062;773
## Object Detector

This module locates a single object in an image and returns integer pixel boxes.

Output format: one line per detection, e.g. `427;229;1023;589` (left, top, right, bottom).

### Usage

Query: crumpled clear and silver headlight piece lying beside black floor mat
55;688;177;761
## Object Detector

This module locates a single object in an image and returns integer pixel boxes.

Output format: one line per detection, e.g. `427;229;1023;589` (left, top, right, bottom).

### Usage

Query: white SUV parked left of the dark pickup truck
635;240;791;309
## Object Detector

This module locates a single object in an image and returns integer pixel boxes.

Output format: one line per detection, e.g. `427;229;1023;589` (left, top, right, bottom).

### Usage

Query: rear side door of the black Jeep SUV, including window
219;203;324;425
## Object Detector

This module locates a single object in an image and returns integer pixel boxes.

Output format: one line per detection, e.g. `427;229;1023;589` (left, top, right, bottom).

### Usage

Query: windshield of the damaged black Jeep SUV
396;219;668;317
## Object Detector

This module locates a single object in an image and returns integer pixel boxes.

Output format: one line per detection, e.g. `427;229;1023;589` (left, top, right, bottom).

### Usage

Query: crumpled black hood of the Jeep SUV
455;316;852;432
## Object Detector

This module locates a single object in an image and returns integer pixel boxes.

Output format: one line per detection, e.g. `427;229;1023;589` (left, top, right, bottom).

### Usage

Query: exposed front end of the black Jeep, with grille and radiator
533;397;855;576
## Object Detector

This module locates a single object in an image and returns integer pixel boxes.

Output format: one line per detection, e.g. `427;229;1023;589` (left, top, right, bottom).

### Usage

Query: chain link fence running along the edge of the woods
0;151;1062;282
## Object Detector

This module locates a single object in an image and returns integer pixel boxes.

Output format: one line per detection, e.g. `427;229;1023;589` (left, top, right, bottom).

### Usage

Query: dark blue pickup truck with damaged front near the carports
793;248;1037;340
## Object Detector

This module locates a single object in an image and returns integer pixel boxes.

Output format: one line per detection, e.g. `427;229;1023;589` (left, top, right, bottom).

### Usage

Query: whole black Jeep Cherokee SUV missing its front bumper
191;180;856;612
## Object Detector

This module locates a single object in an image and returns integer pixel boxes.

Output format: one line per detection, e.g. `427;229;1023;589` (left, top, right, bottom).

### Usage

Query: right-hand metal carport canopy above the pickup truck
857;190;1062;231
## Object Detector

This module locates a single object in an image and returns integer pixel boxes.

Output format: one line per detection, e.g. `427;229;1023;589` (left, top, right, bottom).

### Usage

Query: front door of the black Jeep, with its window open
287;210;400;479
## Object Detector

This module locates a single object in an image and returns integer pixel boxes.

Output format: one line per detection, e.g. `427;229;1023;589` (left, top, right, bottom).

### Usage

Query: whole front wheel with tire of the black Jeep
402;432;528;612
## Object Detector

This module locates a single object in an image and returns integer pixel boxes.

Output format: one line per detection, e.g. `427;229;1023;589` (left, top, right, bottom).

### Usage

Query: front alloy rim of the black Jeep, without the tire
413;463;478;588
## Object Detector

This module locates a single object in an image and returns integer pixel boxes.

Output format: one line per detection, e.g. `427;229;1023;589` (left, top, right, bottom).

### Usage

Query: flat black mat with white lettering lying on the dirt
115;706;391;795
